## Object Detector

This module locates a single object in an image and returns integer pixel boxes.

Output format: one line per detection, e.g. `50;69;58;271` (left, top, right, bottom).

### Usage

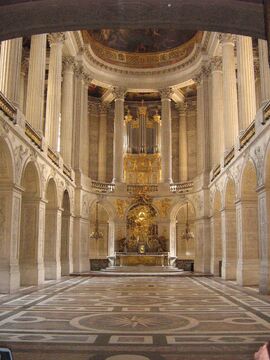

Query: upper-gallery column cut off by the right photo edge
258;39;270;103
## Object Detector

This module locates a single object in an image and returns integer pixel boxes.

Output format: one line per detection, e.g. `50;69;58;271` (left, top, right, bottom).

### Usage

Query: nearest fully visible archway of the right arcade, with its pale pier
236;159;260;285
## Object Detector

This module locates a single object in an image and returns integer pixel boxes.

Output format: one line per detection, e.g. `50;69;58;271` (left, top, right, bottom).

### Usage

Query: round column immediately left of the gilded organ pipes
113;88;126;183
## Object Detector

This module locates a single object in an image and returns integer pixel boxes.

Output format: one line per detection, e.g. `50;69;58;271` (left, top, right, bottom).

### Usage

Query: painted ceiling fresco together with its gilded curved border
82;29;203;69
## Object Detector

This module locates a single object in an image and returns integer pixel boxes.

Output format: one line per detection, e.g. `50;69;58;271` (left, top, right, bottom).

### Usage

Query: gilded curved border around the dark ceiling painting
82;30;203;68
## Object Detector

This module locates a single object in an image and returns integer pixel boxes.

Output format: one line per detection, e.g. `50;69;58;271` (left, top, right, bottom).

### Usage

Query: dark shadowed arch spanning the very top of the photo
0;0;268;40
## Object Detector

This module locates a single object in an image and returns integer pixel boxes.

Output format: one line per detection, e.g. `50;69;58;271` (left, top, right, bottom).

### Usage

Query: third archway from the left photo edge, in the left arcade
44;177;61;280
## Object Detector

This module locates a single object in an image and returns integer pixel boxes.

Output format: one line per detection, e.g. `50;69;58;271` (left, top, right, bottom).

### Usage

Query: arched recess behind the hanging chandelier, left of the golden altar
89;201;110;259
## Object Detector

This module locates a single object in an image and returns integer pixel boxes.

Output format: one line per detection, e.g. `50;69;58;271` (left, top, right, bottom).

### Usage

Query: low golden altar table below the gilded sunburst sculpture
115;252;168;266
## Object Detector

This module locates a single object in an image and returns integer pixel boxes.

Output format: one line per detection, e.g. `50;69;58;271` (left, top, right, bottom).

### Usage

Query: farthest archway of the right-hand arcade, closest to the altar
210;190;222;276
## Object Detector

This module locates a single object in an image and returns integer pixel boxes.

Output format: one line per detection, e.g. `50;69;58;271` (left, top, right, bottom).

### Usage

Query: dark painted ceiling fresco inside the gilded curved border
88;29;196;53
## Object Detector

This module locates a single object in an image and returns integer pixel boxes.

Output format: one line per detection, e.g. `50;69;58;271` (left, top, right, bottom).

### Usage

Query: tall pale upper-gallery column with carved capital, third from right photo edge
220;34;238;151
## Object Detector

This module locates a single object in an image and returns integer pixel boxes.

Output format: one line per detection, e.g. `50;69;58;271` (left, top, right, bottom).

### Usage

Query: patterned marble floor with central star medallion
0;276;270;360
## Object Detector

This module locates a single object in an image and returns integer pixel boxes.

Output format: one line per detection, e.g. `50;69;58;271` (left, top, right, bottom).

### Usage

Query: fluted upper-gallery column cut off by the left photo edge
0;38;22;106
